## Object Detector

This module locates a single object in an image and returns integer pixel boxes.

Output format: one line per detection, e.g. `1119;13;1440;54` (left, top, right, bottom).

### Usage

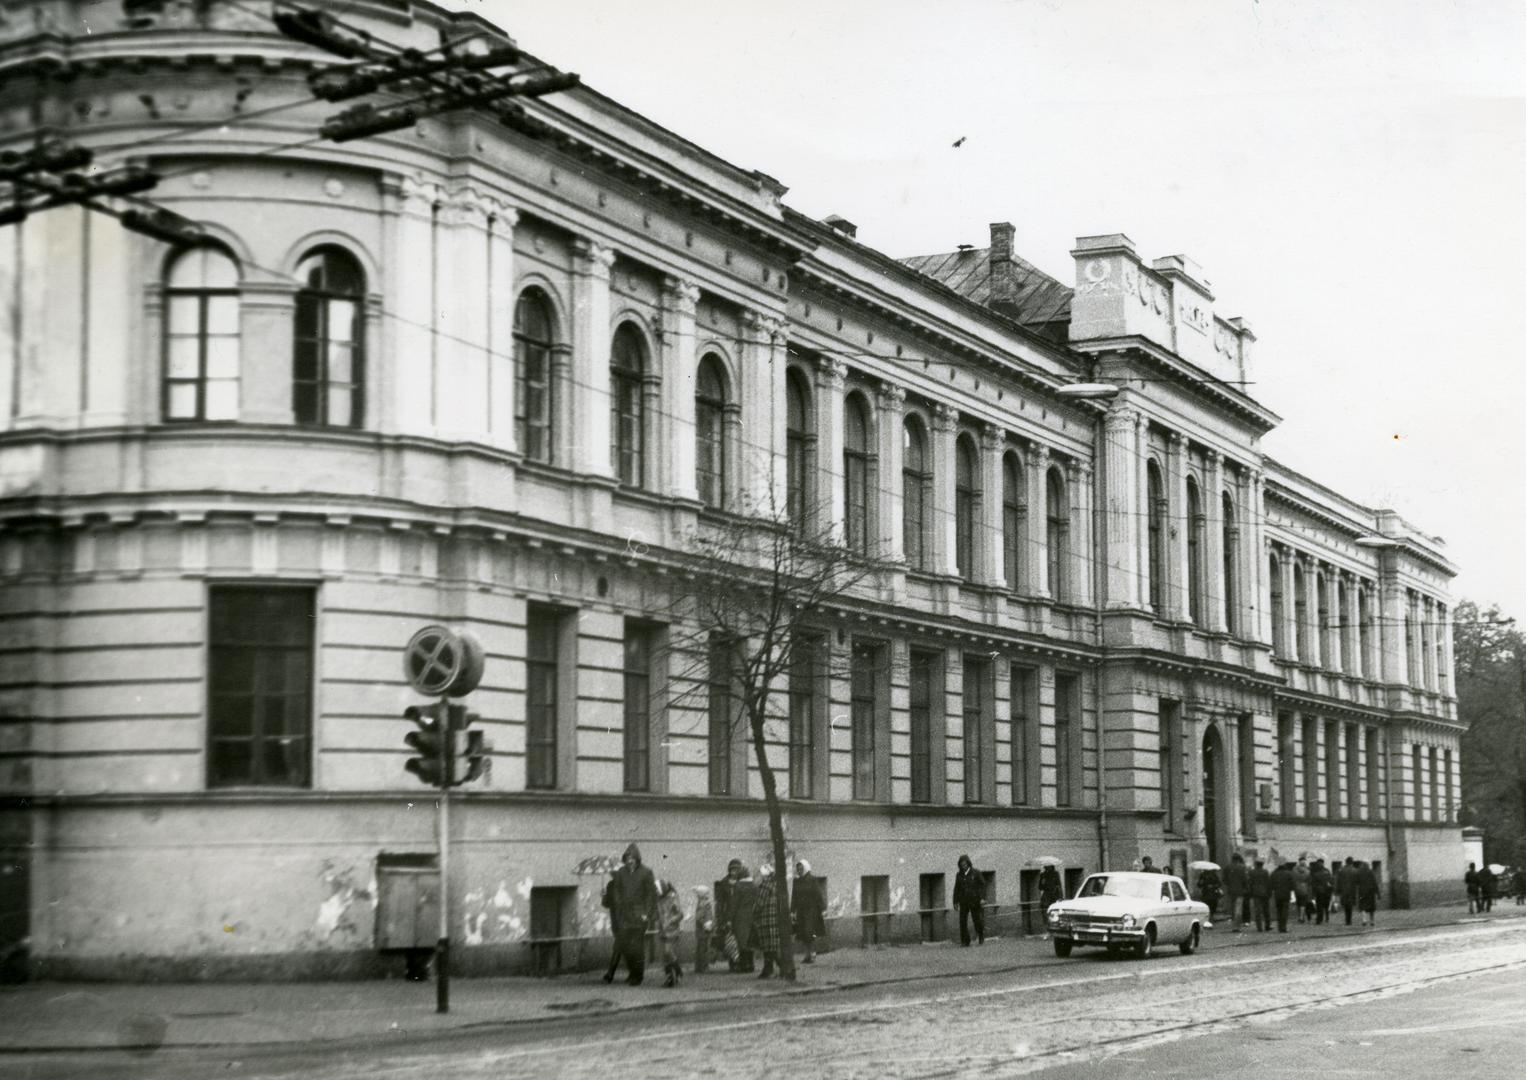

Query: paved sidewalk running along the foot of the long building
0;903;1526;1054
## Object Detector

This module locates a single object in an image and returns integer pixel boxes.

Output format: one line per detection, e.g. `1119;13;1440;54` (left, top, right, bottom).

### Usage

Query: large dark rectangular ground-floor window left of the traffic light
208;586;314;787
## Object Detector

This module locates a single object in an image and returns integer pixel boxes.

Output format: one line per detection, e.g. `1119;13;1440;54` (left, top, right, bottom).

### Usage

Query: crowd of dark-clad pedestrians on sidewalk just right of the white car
1199;853;1380;934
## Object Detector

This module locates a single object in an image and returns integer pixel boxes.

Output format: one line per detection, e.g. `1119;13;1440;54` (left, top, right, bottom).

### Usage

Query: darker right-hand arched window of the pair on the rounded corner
291;247;366;427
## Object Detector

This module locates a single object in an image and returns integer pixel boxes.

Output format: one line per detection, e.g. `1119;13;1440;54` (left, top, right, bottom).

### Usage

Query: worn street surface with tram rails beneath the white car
11;920;1526;1080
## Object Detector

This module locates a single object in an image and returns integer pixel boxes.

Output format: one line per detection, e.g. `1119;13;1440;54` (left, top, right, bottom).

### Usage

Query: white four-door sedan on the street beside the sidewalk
1047;871;1209;958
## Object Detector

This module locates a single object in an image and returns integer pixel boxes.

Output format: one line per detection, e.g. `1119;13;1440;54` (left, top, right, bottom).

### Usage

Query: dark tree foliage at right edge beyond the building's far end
1453;599;1526;865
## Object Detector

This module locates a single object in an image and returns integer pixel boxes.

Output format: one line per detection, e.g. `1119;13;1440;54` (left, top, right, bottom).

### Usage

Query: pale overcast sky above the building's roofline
449;0;1526;619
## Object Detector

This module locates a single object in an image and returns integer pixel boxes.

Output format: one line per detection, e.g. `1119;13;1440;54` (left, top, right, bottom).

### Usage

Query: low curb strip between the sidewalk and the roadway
0;914;1508;1060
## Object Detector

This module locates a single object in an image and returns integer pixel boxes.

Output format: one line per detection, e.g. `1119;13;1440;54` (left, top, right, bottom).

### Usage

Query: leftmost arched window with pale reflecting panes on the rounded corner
162;247;238;419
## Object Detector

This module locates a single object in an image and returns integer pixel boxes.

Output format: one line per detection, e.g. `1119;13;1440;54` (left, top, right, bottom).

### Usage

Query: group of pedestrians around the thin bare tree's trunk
603;844;827;987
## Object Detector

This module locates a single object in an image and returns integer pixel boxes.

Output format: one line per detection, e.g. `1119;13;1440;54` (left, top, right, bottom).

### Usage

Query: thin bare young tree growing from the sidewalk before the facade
668;494;891;981
